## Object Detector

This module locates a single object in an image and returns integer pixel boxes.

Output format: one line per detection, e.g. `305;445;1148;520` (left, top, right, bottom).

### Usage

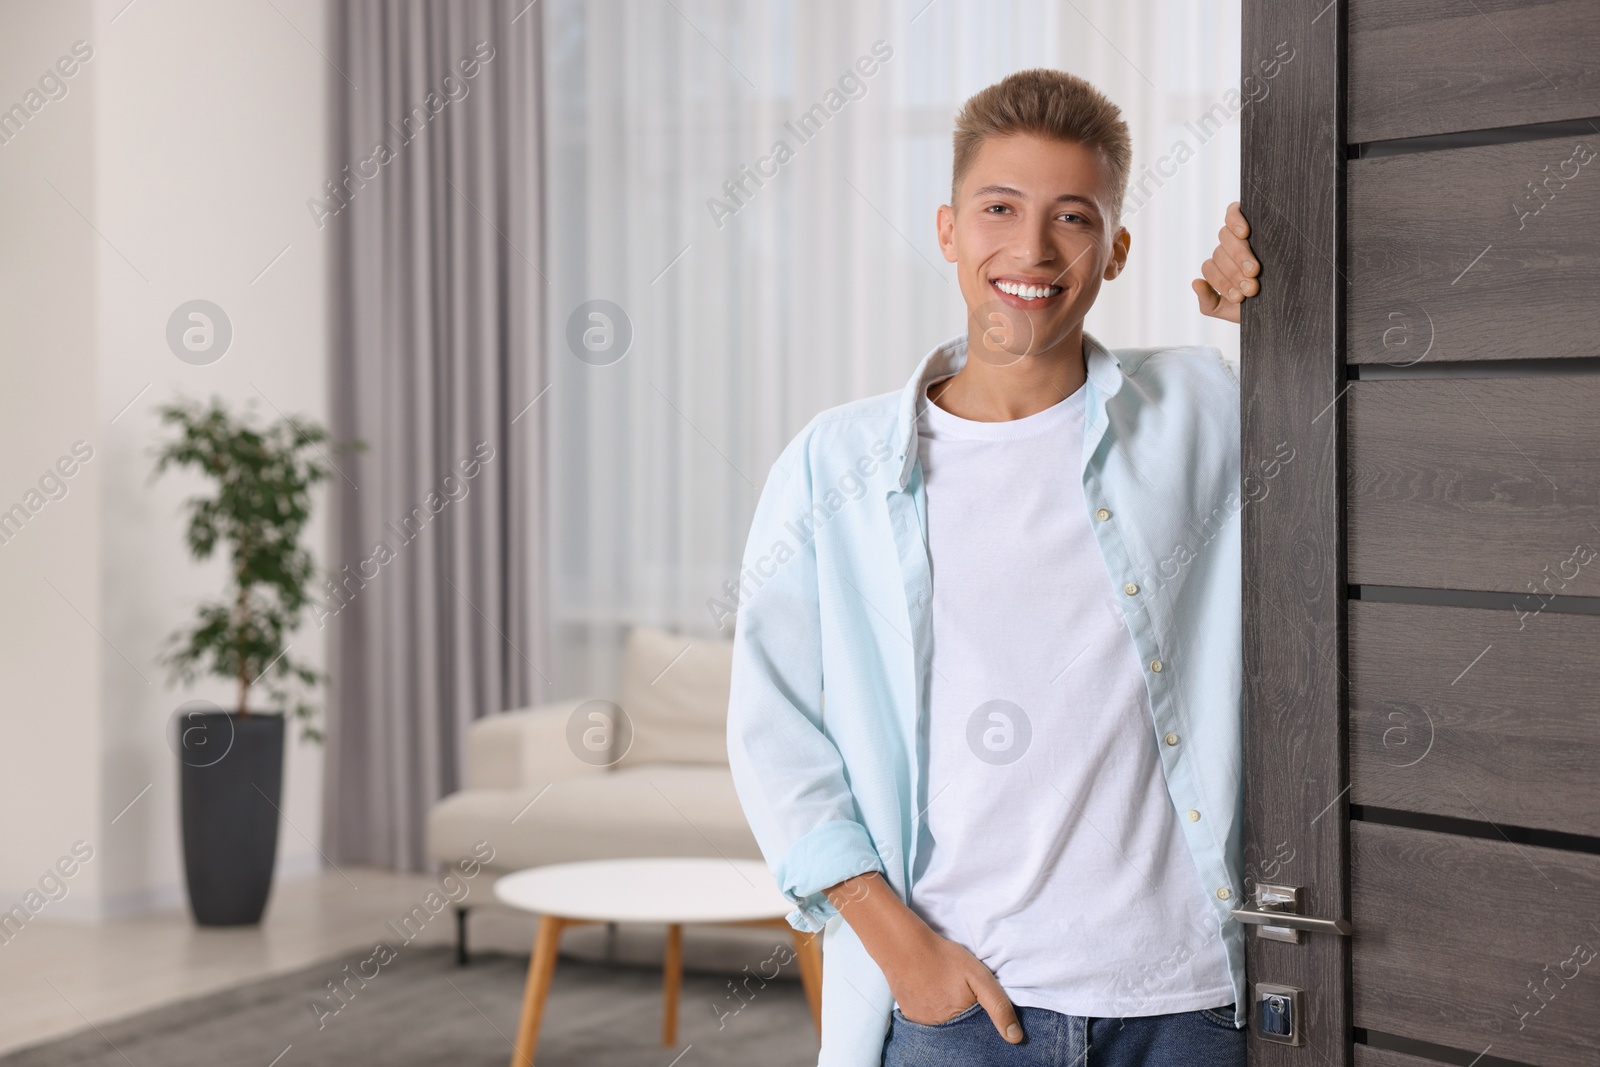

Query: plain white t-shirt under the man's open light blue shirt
910;374;1234;1017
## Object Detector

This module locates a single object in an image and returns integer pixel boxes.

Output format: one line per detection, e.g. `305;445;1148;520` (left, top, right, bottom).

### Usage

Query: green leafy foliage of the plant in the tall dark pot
152;398;363;741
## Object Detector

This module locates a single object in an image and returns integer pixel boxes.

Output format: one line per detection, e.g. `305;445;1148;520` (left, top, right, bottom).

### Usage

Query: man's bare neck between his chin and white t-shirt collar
928;323;1088;422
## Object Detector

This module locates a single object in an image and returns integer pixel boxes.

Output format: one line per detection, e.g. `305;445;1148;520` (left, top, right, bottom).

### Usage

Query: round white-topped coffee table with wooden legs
494;859;822;1067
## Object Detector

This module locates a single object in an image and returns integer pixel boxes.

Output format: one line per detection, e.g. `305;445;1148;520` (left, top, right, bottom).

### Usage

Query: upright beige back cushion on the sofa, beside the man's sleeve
616;627;733;768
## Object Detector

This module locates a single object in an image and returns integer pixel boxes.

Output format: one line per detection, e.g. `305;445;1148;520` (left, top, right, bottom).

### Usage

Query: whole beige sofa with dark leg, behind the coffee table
427;627;762;961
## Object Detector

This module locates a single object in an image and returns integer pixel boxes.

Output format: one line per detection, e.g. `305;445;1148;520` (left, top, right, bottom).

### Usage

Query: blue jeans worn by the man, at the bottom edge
882;1005;1245;1067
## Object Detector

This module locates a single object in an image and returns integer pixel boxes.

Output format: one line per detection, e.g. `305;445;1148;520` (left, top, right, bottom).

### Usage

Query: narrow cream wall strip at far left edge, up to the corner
0;0;109;907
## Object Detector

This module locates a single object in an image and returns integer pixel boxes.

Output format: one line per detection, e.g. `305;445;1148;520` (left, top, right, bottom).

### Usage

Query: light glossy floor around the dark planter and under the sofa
0;867;800;1053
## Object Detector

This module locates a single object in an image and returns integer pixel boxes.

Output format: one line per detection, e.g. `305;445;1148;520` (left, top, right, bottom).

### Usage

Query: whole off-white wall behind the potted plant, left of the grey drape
0;0;332;915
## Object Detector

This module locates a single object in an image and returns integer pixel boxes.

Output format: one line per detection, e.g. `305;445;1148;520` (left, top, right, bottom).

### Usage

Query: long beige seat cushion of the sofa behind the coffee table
427;767;762;872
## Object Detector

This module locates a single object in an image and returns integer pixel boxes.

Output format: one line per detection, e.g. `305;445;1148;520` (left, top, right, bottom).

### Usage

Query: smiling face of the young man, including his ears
938;134;1128;365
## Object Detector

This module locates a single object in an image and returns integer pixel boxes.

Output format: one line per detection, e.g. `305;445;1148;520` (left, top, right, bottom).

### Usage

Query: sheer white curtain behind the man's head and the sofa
539;0;1248;694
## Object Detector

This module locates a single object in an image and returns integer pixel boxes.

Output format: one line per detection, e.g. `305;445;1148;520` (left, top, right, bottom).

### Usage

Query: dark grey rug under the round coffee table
0;947;818;1067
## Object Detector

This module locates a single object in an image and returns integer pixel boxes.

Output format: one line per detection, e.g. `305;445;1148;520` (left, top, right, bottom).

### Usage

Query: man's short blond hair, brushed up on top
950;67;1133;221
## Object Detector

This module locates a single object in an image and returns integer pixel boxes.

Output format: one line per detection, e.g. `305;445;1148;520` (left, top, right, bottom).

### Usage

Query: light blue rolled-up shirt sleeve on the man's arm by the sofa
728;434;883;931
